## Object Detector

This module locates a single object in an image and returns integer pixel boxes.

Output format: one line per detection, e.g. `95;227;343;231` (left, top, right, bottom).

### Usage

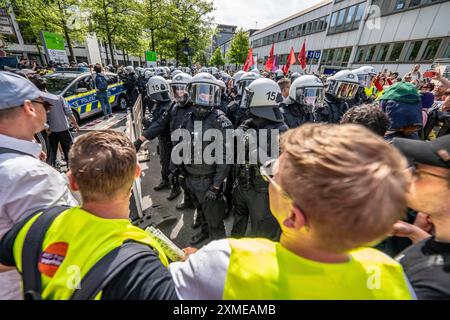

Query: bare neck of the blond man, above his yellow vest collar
280;235;350;263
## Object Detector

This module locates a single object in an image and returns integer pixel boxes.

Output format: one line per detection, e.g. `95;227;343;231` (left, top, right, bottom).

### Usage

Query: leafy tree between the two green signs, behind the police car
83;0;142;65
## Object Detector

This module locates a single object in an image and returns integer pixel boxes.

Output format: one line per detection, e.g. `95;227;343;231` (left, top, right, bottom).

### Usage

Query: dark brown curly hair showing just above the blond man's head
341;104;390;137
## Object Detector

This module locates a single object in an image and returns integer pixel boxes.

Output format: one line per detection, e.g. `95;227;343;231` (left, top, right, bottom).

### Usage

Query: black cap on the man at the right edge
393;135;450;169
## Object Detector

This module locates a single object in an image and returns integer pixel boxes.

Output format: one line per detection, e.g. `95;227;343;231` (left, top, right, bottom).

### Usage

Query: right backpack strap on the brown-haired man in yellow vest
71;241;154;300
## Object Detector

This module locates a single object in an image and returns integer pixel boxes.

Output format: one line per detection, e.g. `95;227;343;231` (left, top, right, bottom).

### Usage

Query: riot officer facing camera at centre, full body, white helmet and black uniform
174;73;233;245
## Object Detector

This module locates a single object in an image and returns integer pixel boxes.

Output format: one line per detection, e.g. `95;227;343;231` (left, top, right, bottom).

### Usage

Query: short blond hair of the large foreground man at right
280;124;408;252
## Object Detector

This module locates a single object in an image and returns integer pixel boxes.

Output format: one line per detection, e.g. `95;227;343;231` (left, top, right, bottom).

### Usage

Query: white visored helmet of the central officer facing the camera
187;72;222;109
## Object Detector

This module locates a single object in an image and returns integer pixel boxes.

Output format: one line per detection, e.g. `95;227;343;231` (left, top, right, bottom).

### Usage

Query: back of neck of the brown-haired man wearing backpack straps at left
81;200;130;219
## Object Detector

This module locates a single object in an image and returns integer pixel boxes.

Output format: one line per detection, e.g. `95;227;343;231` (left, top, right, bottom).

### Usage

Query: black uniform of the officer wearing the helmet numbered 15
231;118;288;240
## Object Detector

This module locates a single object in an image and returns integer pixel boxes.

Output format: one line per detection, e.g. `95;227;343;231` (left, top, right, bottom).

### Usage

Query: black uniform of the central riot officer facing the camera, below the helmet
176;109;233;240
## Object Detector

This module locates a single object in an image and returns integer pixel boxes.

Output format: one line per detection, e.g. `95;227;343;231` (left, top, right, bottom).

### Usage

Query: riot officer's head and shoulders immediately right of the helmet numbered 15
281;75;324;129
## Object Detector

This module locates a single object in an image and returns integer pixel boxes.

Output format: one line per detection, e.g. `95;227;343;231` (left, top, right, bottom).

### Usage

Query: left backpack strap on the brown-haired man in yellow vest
22;206;70;300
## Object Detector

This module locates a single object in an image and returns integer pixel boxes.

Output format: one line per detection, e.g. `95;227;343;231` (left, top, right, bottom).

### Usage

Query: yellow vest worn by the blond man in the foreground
223;239;413;300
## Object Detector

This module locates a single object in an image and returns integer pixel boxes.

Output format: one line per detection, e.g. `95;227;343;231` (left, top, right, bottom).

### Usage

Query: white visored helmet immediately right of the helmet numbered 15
289;75;324;108
